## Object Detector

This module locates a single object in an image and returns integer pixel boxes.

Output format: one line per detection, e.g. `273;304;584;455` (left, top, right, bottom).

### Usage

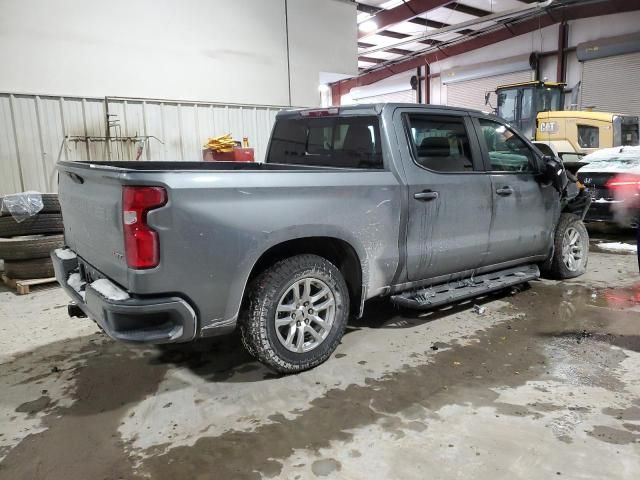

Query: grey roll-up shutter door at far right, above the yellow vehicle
581;53;640;115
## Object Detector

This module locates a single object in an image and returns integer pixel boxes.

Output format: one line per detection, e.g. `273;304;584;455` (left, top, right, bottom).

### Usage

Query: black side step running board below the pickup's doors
391;265;540;310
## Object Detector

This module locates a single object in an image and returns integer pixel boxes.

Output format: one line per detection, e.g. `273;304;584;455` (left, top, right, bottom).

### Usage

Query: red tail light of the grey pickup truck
122;187;167;269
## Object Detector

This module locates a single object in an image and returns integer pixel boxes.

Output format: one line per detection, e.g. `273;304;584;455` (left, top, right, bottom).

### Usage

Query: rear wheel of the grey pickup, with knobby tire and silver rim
239;255;349;373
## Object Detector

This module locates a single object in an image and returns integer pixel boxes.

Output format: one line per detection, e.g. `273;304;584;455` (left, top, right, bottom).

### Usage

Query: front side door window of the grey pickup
478;118;537;172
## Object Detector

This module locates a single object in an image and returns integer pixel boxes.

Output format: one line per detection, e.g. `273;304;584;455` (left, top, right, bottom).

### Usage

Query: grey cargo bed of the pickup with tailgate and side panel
58;156;401;342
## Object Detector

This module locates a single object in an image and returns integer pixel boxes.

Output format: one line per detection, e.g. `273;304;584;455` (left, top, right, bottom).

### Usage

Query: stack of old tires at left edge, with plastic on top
0;193;64;280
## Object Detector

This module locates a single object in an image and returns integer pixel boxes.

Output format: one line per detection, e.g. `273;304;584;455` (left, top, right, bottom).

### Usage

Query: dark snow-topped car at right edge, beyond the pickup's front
577;146;640;225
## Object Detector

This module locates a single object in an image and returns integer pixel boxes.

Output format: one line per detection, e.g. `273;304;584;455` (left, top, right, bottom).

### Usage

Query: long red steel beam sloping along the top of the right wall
338;0;640;94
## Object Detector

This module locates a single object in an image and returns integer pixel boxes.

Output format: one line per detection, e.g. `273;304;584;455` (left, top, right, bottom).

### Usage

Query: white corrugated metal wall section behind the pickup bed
0;93;284;194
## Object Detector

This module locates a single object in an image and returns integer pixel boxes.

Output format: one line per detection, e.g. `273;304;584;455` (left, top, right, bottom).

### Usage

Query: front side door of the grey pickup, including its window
475;118;560;266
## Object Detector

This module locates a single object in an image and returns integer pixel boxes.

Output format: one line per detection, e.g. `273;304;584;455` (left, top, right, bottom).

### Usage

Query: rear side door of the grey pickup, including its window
394;109;491;281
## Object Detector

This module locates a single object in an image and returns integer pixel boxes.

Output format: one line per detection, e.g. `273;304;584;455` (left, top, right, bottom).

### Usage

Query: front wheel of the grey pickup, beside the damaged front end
542;213;589;280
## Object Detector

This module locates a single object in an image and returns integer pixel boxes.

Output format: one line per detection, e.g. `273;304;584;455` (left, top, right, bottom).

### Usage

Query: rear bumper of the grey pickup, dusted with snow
51;250;198;343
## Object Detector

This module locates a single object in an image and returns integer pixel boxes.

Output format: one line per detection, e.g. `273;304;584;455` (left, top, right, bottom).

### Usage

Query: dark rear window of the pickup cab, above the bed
267;116;383;169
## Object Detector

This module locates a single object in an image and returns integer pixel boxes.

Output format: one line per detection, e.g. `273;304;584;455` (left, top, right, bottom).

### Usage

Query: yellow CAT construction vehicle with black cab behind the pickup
486;81;640;171
